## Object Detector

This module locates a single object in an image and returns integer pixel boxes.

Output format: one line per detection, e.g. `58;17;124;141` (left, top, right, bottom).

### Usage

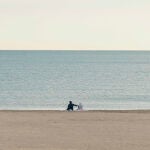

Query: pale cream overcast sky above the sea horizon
0;0;150;50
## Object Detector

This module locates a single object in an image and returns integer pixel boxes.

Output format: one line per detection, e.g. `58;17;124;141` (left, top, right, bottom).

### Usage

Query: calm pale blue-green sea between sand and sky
0;51;150;110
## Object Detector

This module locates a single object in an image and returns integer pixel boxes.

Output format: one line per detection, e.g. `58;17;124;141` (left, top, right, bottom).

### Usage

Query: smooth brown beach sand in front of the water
0;111;150;150
